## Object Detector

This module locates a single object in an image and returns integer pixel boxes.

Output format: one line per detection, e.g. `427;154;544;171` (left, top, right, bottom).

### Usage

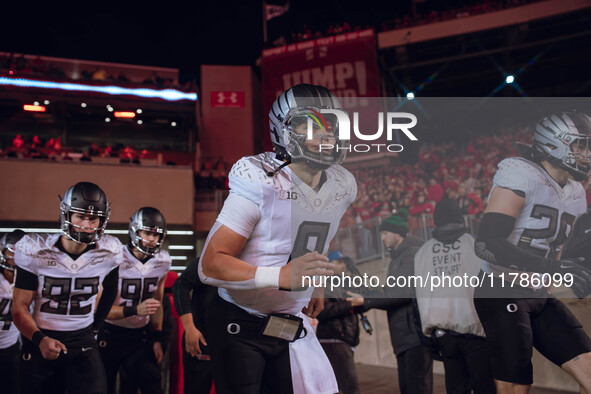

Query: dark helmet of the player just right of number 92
129;207;166;256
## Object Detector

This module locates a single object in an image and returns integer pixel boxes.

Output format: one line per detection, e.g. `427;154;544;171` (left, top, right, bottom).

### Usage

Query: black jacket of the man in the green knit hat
365;235;424;356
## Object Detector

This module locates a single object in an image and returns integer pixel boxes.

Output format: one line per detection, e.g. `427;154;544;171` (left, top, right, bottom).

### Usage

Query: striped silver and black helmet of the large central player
269;84;349;170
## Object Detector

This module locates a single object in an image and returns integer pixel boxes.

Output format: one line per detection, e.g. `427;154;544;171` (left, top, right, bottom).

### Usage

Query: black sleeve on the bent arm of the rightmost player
474;212;559;273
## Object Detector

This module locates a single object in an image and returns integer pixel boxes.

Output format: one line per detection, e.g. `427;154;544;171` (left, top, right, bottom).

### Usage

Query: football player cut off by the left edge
0;230;25;394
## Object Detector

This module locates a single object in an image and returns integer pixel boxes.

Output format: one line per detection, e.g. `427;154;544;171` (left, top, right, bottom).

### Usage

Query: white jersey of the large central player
212;152;357;315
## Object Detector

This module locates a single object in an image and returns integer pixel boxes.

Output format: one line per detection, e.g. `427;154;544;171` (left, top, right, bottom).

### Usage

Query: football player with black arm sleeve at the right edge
474;112;591;393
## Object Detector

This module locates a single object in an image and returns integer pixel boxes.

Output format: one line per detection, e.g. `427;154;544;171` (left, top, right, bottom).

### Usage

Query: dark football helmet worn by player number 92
60;182;111;245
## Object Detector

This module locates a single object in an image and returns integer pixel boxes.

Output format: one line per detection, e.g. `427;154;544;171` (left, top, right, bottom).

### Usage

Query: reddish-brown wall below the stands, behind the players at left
0;159;195;225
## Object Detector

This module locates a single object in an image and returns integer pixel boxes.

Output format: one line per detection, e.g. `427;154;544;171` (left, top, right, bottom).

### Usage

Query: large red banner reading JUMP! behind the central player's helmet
262;29;380;149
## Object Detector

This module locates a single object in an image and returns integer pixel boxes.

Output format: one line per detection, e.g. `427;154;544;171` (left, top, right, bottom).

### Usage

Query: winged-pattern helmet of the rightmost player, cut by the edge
533;112;591;181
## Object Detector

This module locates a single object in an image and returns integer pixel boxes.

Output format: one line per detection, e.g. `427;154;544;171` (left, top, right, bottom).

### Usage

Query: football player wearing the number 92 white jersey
12;182;122;394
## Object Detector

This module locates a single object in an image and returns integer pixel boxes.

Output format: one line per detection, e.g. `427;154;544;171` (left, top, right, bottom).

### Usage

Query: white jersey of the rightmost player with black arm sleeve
483;157;587;273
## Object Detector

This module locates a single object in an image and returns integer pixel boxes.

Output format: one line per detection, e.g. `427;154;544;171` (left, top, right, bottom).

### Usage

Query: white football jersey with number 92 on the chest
14;234;122;331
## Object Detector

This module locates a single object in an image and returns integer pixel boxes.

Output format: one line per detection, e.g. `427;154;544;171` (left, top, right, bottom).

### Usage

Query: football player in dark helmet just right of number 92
98;207;171;394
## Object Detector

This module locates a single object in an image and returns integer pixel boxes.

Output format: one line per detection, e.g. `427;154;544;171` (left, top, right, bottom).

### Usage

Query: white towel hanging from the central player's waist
289;313;339;394
